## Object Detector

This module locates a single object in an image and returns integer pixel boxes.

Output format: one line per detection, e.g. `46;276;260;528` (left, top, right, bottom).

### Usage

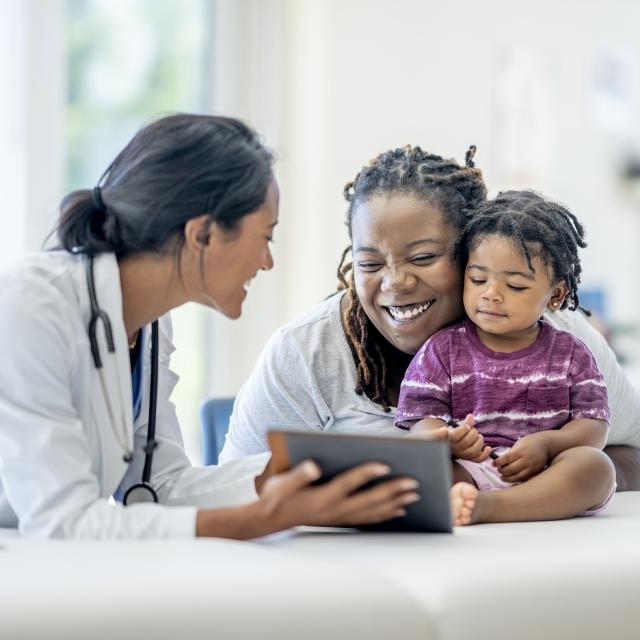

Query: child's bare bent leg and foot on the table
451;447;615;524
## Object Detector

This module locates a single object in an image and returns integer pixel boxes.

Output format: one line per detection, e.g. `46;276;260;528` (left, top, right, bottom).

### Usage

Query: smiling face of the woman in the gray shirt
351;194;463;354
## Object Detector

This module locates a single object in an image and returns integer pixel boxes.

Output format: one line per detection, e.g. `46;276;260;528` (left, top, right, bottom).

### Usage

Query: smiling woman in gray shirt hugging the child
220;142;640;486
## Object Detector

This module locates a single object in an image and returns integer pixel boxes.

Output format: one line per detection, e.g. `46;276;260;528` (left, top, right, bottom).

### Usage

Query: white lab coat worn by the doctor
0;252;267;539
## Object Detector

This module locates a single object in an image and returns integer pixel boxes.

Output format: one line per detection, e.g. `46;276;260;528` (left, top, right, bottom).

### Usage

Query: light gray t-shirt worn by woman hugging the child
220;294;640;463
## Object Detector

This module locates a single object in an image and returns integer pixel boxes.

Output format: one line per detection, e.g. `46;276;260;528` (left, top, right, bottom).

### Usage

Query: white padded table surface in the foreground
0;492;640;640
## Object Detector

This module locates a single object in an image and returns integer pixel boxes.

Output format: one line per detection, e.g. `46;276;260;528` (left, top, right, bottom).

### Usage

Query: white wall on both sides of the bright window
6;0;640;395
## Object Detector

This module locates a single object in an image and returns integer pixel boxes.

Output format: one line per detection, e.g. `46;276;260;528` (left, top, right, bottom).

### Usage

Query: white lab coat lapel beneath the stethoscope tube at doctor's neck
79;254;133;497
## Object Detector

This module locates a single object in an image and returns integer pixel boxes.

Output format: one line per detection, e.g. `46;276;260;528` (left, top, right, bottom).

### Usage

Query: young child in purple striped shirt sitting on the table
396;191;615;525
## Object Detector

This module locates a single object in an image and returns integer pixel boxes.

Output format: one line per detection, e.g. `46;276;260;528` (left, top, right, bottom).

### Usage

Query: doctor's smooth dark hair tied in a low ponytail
56;114;273;257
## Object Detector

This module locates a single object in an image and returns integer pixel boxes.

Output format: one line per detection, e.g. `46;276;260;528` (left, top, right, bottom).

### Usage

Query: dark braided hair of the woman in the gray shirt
338;145;487;411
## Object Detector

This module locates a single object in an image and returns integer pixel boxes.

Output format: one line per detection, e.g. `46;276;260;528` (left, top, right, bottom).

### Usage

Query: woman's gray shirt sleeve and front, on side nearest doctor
220;294;397;462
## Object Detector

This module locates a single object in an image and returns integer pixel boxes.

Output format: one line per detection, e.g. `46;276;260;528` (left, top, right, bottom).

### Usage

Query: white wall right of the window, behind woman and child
204;0;640;393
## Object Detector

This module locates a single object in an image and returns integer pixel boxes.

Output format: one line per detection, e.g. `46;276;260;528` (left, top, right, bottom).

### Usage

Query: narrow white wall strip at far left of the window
0;0;65;264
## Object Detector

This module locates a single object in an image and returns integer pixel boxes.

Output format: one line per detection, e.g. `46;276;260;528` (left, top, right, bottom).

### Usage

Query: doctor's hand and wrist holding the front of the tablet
196;461;420;539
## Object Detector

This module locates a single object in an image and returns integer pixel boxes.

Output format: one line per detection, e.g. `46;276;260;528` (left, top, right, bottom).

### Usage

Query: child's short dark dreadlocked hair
454;191;587;311
